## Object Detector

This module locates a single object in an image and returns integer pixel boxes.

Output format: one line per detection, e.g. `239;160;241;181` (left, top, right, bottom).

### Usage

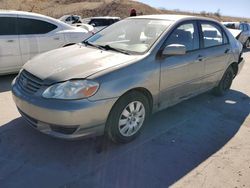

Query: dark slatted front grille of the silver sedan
17;70;43;94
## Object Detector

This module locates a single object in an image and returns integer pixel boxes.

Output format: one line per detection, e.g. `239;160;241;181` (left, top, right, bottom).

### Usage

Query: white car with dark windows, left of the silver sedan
0;11;92;75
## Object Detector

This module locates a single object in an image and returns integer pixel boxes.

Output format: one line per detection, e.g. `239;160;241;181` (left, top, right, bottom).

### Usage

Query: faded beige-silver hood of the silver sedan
23;44;139;83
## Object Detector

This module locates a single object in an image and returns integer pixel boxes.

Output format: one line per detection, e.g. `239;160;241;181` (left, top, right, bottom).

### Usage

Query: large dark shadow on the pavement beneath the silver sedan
0;90;250;188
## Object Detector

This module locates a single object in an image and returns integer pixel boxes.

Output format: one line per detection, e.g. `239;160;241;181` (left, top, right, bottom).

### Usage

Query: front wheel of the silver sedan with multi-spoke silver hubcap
105;91;150;143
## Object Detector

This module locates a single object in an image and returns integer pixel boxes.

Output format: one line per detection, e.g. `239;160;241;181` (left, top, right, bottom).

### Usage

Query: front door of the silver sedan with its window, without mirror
159;21;204;108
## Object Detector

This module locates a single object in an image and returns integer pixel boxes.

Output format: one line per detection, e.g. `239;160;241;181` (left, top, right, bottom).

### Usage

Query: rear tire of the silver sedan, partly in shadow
214;66;234;96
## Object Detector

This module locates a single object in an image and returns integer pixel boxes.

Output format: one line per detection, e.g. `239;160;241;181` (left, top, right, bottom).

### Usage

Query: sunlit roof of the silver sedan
129;14;216;22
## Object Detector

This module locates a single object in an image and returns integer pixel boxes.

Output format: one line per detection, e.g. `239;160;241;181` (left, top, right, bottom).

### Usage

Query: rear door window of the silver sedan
201;23;227;48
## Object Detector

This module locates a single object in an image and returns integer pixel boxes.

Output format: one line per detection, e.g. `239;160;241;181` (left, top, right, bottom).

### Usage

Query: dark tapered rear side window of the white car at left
17;18;57;35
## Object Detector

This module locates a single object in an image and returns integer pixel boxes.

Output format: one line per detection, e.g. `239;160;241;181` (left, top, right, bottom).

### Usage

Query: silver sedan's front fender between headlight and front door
89;55;160;109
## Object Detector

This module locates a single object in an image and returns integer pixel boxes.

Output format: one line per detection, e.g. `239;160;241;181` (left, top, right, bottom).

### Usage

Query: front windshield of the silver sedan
87;19;172;53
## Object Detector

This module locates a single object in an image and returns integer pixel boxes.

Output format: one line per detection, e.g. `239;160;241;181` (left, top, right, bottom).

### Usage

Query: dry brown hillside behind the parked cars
0;0;250;21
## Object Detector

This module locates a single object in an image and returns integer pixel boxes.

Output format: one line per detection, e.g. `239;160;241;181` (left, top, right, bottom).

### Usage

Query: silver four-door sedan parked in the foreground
12;15;244;143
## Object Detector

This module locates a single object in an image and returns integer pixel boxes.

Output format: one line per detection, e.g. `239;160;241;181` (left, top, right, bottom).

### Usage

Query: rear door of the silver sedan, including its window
200;21;232;90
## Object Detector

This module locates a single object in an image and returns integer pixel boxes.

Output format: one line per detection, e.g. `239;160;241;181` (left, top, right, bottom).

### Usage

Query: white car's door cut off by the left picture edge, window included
0;15;21;73
